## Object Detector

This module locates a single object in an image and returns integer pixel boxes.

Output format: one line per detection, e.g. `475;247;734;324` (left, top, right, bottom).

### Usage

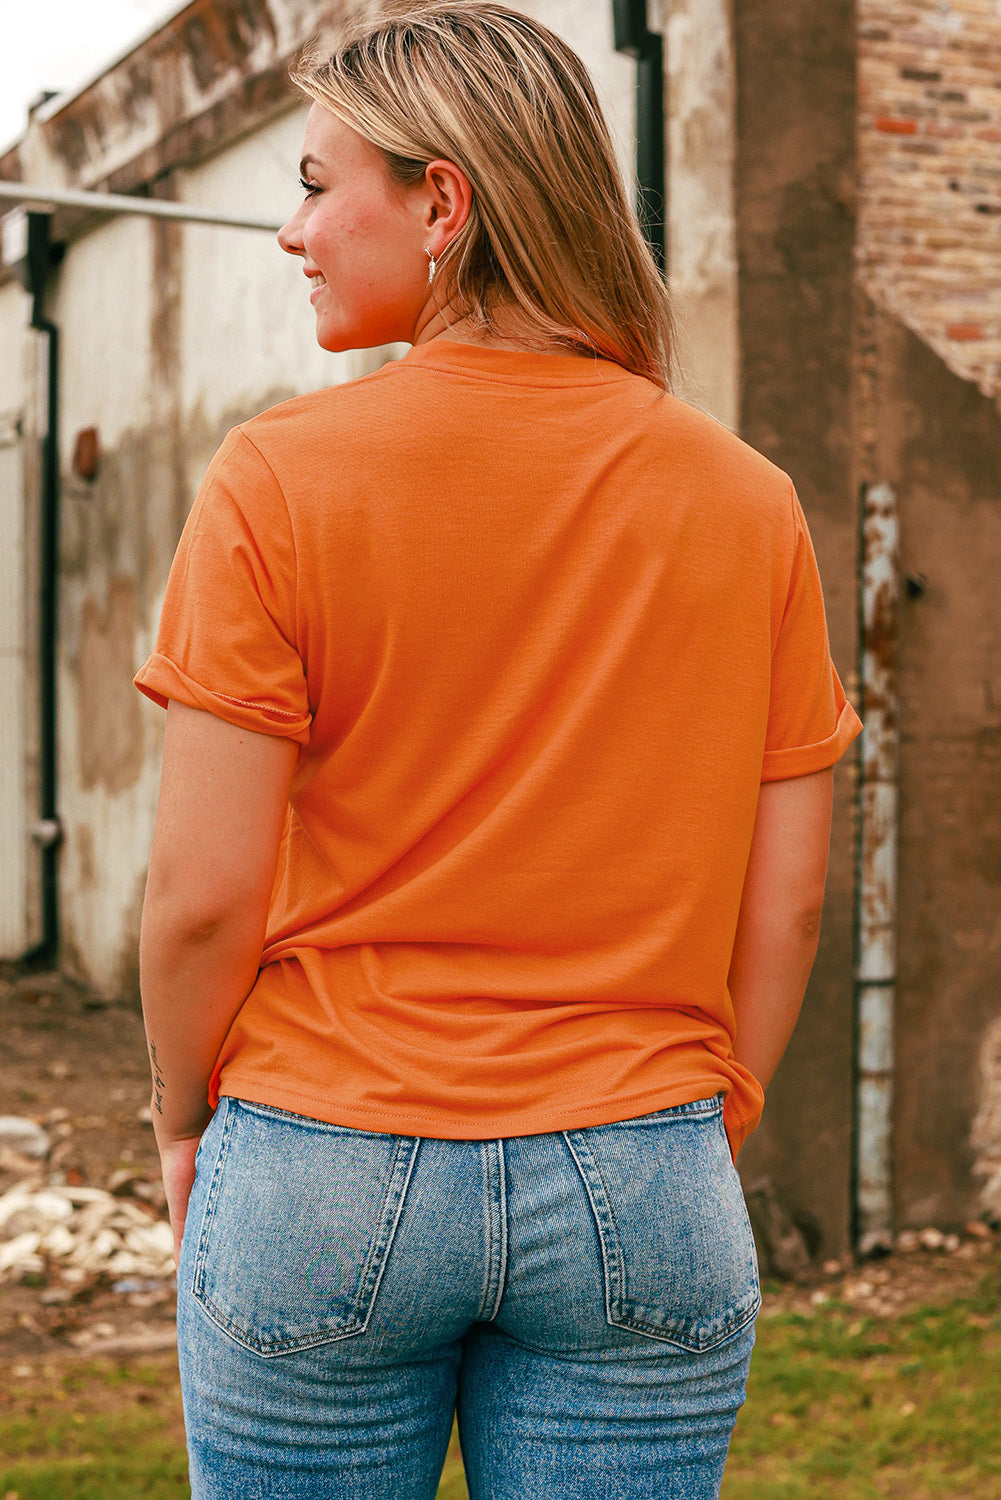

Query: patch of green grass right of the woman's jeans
723;1260;1001;1500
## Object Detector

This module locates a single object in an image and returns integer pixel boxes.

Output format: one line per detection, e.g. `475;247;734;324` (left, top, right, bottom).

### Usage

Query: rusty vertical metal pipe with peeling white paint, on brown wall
854;485;900;1256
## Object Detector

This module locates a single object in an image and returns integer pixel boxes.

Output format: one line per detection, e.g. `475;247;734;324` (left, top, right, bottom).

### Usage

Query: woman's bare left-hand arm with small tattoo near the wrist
140;702;299;1253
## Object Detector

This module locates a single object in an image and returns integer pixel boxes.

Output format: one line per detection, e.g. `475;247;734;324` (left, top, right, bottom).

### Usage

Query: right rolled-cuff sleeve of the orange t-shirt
761;494;861;782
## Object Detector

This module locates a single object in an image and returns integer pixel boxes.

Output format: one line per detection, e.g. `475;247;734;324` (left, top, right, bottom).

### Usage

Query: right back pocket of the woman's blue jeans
564;1098;761;1352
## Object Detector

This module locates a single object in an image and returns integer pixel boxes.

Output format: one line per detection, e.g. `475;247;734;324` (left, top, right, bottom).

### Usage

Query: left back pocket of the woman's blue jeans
192;1100;419;1355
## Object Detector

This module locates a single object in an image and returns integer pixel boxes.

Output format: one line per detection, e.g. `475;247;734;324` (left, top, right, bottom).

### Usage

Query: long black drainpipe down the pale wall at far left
23;213;62;965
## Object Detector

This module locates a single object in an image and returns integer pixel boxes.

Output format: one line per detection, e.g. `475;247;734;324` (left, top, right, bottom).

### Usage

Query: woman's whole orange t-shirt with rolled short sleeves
137;339;858;1149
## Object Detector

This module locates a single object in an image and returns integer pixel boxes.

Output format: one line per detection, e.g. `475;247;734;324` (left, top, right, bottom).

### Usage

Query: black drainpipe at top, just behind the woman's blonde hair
612;0;668;272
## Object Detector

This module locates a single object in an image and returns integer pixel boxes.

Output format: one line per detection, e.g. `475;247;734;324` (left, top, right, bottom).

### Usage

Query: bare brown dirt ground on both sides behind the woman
0;969;1001;1362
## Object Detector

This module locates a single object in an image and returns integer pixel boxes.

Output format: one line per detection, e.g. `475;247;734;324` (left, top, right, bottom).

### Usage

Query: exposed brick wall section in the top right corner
857;0;1001;398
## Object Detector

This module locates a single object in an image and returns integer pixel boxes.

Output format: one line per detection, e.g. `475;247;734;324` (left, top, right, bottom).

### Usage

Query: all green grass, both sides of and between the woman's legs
0;1278;1001;1500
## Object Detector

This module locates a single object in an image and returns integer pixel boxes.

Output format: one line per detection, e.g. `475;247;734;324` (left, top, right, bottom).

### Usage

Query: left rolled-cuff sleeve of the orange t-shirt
135;428;311;744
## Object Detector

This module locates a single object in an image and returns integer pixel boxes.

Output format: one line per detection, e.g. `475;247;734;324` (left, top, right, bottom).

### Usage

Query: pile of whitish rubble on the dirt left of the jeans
0;1182;174;1286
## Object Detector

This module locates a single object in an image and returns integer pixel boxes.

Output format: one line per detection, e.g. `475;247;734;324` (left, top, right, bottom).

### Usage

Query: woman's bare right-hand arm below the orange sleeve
729;768;834;1089
